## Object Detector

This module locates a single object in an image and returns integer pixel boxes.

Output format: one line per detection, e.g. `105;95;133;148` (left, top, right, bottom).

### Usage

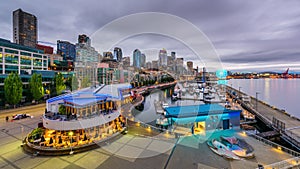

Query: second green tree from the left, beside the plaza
29;73;45;101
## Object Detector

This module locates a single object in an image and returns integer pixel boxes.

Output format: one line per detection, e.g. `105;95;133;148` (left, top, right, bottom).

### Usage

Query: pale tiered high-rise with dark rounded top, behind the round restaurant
74;35;99;86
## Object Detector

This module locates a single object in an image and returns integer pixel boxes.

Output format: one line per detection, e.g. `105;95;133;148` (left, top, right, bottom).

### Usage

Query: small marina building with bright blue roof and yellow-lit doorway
165;104;242;133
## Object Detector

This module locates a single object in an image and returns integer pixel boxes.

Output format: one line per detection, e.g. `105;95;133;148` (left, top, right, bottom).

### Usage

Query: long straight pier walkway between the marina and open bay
228;87;300;149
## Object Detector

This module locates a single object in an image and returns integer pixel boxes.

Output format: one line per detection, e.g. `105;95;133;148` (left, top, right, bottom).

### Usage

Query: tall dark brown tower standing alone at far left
13;9;37;48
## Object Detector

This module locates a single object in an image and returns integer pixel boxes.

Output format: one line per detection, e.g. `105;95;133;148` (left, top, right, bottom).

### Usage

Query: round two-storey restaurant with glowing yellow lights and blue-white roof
30;84;131;151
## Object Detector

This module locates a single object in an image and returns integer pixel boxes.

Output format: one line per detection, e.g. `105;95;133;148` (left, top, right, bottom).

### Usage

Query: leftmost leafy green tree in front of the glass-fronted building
4;73;23;107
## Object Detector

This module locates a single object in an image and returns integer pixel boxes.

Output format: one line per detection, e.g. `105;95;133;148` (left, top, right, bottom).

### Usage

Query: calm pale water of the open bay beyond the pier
227;79;300;118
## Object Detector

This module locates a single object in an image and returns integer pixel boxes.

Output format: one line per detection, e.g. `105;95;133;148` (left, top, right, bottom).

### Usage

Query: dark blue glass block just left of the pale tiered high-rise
57;40;76;62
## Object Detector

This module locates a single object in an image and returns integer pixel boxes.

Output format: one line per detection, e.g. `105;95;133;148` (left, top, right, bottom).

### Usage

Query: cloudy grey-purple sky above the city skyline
0;0;300;72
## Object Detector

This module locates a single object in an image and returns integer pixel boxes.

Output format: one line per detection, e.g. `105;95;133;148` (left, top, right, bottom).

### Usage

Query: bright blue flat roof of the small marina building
165;104;241;118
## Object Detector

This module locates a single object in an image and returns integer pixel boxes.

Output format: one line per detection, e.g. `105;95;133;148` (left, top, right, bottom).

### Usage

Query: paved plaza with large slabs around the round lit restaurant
0;105;291;169
